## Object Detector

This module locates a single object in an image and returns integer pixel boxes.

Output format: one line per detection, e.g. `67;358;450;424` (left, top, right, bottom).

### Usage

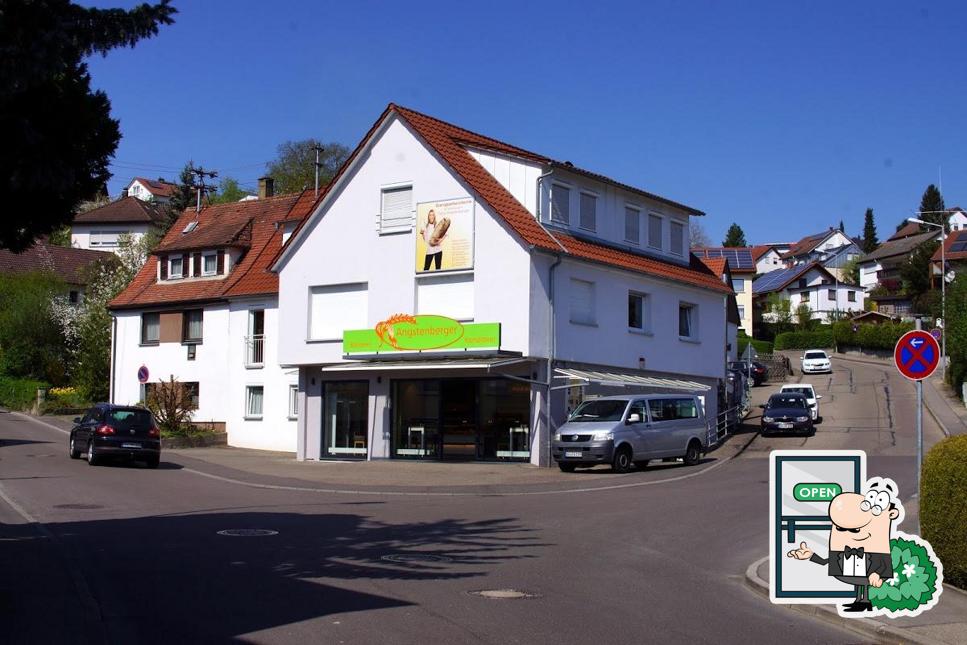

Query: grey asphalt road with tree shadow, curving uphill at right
0;354;941;644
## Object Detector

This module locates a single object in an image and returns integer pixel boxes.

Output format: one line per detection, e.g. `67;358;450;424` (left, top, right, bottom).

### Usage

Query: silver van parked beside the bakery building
552;394;708;473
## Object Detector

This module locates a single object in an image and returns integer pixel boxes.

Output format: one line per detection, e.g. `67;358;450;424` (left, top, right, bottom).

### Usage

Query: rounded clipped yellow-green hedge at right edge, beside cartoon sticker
920;435;967;588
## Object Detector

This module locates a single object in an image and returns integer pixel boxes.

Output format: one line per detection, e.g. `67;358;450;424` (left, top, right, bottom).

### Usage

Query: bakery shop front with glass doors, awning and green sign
306;314;543;461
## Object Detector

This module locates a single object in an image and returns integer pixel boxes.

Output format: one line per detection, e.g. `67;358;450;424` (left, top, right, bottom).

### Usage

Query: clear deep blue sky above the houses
85;0;967;243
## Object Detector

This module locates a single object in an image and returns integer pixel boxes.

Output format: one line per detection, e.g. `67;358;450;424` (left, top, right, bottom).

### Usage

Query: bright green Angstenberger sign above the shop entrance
342;314;500;355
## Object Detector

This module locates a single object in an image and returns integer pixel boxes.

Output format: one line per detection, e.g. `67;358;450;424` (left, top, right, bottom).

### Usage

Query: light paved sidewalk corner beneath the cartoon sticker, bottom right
745;556;967;645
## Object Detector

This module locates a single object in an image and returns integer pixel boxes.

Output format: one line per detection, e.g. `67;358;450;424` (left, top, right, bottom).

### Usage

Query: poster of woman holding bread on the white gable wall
416;197;473;273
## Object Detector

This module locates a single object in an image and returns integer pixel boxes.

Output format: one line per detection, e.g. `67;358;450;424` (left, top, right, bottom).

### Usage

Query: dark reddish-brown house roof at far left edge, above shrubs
0;242;114;304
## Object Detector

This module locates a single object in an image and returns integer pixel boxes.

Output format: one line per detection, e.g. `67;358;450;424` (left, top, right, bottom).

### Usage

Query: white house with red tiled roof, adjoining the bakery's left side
110;182;322;451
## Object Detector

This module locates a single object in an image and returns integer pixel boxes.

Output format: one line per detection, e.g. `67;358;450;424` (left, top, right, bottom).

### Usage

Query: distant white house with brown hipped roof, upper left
71;197;165;252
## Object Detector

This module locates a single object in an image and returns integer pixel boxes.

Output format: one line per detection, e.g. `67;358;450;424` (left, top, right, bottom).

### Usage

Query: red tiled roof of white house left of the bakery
109;191;316;309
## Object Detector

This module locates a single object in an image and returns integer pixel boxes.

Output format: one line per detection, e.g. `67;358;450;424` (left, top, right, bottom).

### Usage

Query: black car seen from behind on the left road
69;403;161;468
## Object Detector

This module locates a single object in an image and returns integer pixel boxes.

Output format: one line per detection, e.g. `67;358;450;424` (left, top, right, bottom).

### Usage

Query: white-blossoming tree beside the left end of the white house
72;234;151;401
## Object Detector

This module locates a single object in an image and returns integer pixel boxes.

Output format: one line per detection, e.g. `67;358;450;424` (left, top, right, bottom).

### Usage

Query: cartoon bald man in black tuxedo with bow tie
786;477;903;612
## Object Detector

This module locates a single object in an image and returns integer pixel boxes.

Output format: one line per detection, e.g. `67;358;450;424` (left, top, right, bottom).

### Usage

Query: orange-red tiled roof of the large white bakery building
272;103;730;291
